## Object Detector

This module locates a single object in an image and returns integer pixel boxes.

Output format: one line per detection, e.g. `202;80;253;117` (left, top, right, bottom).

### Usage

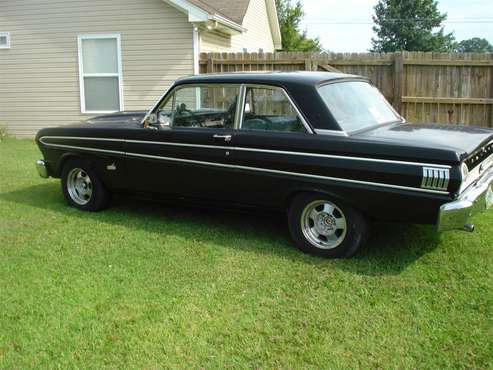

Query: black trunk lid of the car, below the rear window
355;123;493;159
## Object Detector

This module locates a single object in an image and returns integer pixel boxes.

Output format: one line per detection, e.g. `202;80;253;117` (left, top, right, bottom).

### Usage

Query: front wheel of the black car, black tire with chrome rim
61;158;111;212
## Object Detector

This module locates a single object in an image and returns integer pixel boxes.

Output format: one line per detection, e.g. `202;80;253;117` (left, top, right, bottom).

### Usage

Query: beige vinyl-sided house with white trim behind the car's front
0;0;281;137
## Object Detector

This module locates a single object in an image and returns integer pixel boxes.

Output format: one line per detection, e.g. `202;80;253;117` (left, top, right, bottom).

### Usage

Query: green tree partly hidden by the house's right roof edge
276;0;322;51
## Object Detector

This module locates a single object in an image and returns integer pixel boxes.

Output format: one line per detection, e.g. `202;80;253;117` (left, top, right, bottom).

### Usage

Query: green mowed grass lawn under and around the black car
0;139;493;369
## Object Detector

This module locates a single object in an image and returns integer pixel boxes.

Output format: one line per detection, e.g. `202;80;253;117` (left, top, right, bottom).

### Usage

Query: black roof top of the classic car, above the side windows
176;71;365;86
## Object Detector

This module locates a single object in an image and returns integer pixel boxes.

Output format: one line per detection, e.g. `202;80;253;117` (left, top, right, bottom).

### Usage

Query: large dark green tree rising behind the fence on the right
372;0;456;52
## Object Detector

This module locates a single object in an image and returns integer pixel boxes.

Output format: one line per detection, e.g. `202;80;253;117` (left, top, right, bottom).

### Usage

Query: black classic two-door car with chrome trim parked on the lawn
36;72;493;257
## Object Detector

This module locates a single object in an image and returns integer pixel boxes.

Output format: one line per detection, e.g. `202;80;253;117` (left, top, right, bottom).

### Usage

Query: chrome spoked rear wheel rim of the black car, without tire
301;200;347;249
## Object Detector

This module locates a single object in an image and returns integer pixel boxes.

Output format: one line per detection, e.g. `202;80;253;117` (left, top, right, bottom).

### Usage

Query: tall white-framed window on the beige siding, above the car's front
78;34;123;113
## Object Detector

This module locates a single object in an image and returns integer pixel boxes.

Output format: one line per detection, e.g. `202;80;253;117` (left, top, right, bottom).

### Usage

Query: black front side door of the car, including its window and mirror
126;84;240;201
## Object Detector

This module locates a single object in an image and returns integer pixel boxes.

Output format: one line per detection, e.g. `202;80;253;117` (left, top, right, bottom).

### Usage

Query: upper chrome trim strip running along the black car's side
40;136;452;169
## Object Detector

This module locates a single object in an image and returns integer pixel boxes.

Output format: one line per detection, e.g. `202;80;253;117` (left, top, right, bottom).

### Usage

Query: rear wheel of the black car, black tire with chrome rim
288;193;368;258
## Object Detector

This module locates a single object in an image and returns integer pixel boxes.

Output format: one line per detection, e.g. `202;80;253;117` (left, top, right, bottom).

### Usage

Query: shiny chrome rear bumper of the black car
437;167;493;231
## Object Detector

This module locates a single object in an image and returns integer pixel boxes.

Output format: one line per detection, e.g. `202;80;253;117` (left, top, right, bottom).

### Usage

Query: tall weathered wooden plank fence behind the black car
200;52;493;127
